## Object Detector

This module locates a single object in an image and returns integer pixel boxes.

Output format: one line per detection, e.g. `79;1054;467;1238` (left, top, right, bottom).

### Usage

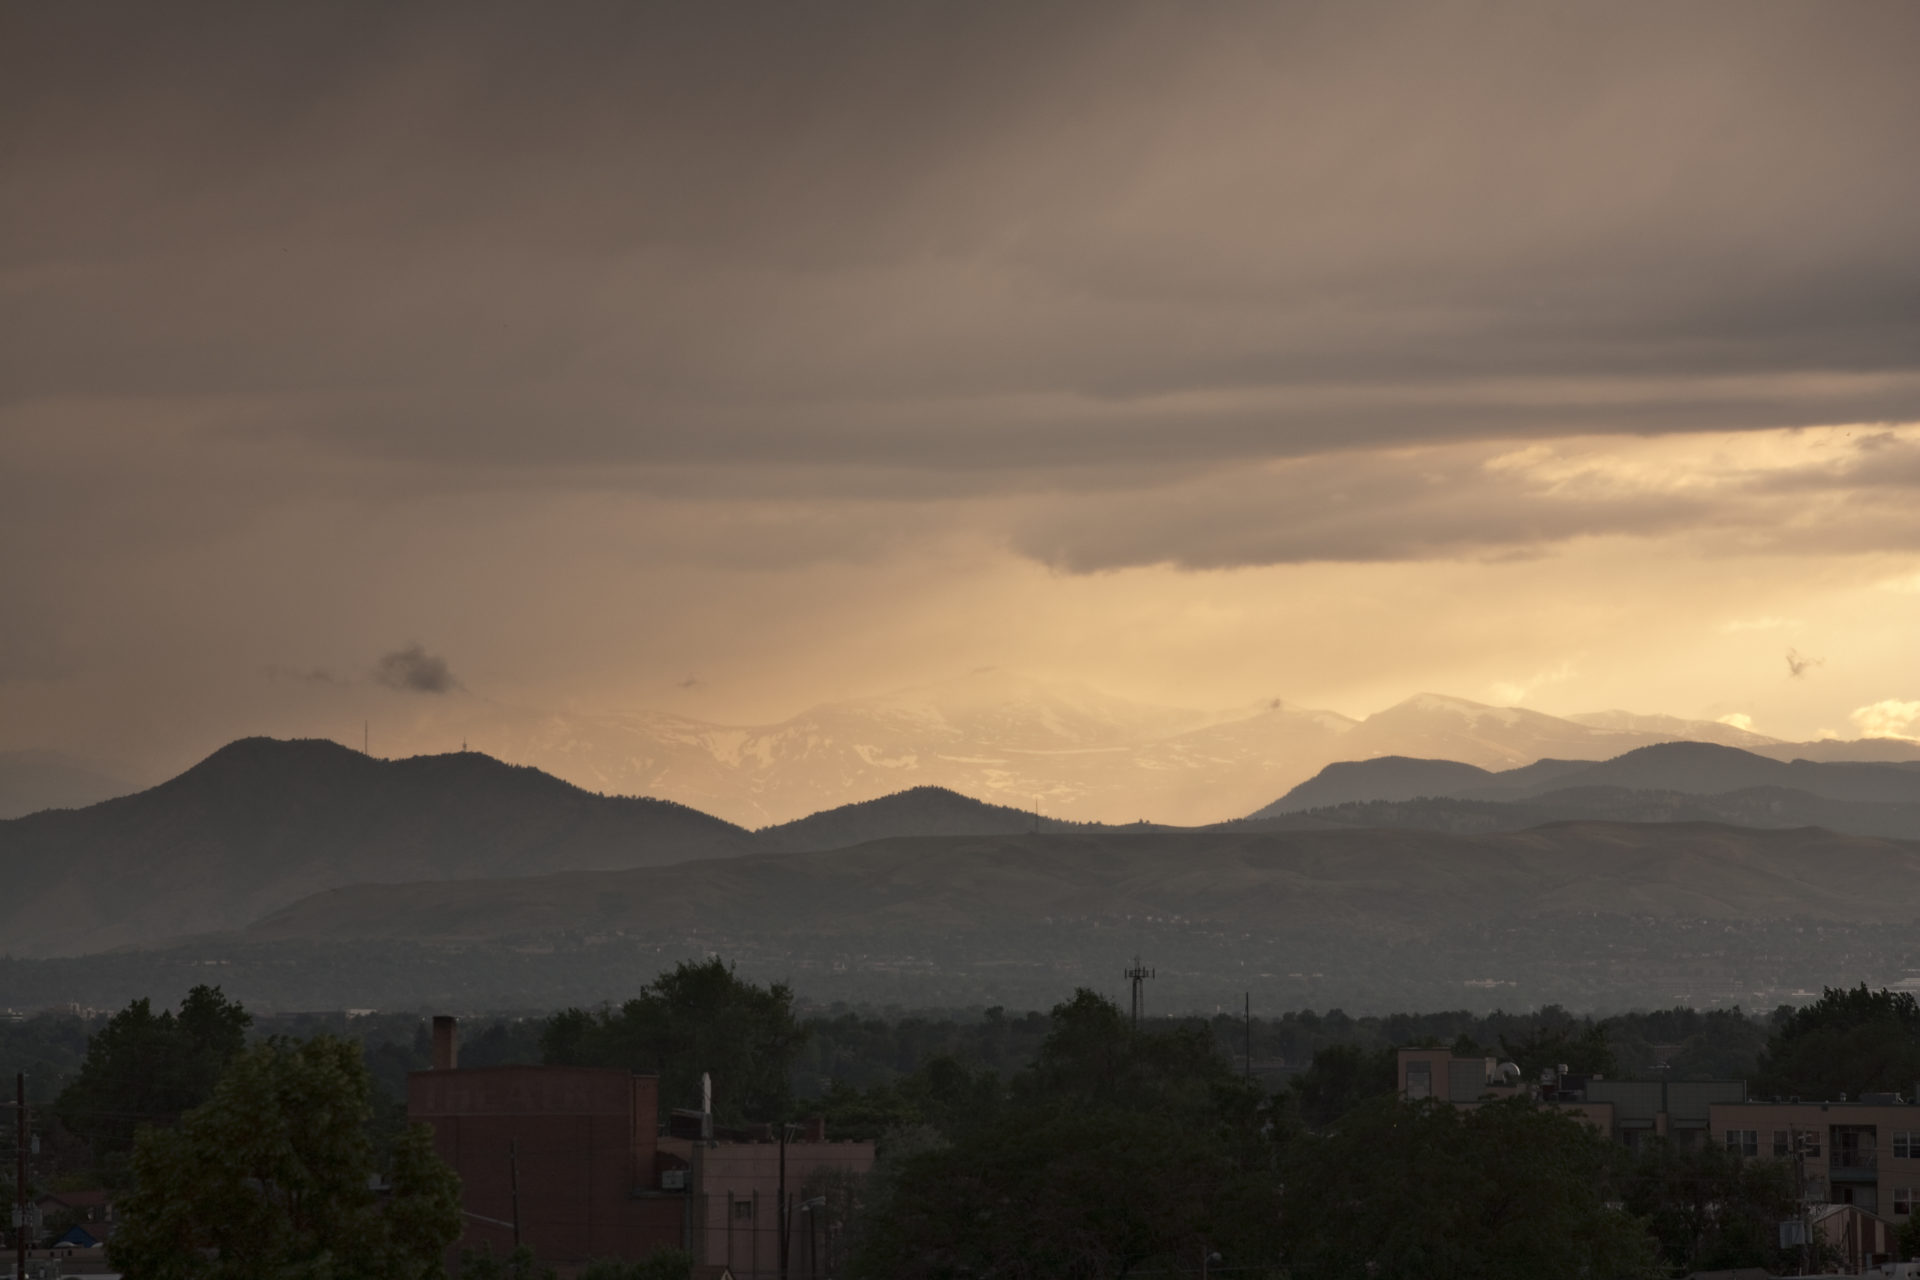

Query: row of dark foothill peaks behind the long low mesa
0;729;1920;956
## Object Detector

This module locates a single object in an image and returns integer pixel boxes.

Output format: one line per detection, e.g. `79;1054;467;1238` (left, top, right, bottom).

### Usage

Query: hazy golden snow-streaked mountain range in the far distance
18;670;1920;827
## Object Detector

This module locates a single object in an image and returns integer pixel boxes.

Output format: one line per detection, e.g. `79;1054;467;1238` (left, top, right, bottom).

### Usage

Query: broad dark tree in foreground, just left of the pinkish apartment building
1281;1098;1661;1280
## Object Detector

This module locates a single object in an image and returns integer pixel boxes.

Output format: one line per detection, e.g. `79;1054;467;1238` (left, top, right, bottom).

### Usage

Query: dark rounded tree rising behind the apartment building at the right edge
1761;983;1920;1098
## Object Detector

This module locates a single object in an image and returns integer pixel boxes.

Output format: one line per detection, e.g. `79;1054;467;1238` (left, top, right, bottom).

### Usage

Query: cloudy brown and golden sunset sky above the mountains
0;2;1920;775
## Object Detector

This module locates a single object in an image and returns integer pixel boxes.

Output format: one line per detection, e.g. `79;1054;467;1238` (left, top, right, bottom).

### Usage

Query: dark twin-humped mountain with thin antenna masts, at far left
0;739;751;956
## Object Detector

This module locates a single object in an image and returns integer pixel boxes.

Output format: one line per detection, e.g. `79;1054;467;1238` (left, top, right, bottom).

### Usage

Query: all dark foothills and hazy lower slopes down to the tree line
11;700;1920;1007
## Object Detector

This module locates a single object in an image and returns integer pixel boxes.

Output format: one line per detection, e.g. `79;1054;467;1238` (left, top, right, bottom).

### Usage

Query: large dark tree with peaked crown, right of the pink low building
854;990;1279;1280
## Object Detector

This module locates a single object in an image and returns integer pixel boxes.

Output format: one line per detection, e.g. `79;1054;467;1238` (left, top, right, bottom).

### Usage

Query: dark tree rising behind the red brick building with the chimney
540;958;806;1125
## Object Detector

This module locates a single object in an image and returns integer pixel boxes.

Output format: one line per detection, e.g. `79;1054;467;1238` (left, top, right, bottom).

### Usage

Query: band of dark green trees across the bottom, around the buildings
22;974;1920;1280
